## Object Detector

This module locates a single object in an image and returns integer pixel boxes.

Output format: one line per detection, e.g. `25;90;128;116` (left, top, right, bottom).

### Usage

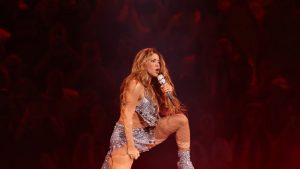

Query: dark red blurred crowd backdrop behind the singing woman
0;0;300;169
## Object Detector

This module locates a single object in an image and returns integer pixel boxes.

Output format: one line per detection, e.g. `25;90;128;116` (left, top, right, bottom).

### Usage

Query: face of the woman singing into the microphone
146;53;160;77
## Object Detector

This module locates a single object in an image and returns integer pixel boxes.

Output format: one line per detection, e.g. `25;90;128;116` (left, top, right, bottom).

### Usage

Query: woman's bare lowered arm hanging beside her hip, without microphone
121;80;144;159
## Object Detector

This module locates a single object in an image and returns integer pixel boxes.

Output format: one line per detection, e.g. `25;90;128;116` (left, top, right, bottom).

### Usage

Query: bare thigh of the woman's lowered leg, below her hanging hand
109;145;133;169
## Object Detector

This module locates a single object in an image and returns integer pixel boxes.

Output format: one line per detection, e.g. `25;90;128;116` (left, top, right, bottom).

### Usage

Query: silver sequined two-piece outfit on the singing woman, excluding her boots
101;90;159;169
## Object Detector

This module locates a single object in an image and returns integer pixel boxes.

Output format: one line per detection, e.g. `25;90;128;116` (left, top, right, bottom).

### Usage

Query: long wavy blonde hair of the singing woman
120;48;187;116
